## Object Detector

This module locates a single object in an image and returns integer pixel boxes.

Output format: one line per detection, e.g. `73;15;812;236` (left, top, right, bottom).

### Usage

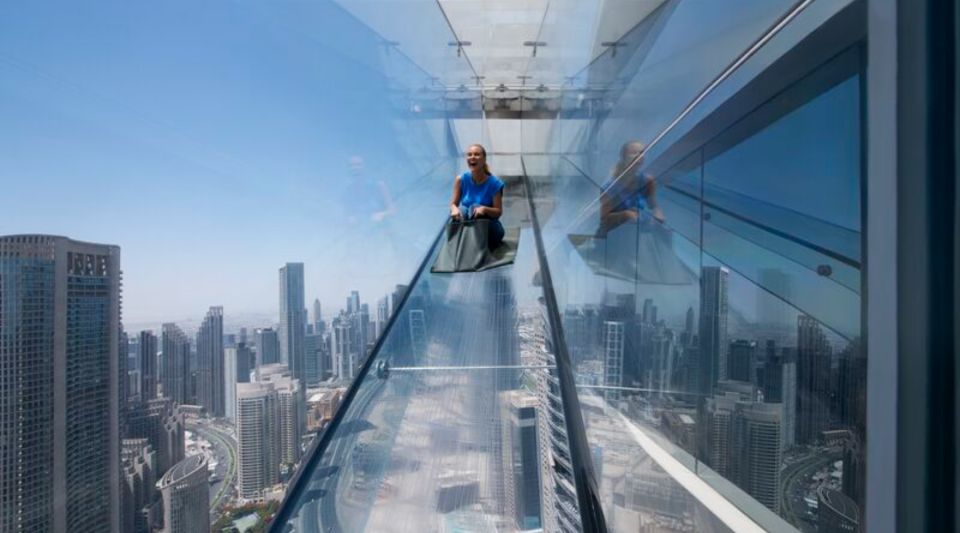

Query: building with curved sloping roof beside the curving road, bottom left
157;453;210;533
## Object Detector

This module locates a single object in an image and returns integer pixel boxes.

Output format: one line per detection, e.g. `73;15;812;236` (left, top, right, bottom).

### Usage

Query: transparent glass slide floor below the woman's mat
278;174;556;531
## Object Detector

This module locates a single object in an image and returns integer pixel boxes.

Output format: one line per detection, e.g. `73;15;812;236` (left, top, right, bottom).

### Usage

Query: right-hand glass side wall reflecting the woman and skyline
525;2;867;531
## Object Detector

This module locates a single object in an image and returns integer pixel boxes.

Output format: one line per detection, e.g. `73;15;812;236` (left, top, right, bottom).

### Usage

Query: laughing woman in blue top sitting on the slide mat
450;144;504;249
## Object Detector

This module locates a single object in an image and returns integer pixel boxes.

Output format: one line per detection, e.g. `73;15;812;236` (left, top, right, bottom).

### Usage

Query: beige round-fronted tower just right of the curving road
237;383;280;500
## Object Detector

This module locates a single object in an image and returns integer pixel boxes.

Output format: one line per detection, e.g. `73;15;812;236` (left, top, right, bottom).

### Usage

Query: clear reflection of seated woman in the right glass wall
600;141;663;234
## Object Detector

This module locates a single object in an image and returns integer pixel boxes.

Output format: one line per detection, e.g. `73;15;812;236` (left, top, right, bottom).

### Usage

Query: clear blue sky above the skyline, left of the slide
0;1;452;322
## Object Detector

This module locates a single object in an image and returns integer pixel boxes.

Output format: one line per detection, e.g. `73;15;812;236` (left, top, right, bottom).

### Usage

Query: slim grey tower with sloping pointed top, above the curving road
197;307;226;417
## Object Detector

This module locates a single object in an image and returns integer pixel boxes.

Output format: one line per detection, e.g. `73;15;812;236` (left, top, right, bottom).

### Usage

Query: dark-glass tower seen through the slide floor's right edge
500;390;542;530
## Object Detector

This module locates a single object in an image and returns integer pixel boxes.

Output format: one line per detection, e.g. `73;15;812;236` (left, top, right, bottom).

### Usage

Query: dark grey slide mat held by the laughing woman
430;219;520;273
